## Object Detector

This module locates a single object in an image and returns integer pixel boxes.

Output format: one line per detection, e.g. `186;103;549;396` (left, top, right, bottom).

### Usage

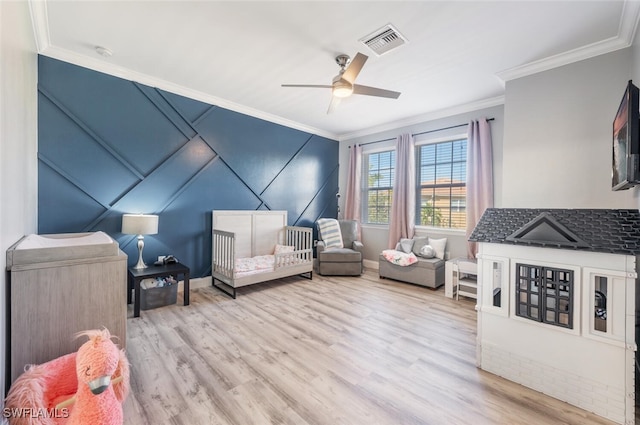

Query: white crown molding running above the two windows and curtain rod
338;96;504;142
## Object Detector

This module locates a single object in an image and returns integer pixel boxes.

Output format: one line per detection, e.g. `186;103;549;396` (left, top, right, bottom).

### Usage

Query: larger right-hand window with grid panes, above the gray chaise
416;139;467;229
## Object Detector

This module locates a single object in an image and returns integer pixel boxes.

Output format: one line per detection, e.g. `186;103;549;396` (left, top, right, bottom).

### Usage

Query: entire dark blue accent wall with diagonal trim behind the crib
38;56;338;277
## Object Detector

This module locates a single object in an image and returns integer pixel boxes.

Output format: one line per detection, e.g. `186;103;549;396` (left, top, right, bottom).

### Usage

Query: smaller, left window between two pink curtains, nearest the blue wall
364;150;396;224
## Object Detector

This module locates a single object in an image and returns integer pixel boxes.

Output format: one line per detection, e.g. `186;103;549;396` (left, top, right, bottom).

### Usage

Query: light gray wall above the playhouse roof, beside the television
501;48;639;208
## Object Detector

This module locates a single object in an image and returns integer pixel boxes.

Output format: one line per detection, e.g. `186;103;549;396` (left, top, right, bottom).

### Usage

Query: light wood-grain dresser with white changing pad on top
5;232;127;389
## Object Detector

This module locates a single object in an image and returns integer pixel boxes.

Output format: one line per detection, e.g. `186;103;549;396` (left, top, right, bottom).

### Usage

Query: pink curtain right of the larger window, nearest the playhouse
467;118;493;258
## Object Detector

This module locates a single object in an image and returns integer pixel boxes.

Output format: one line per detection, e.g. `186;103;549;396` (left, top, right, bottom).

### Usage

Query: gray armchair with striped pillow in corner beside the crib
316;220;363;276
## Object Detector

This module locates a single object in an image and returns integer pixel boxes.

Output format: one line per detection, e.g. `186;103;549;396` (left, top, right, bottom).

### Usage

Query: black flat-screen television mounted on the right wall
611;80;640;190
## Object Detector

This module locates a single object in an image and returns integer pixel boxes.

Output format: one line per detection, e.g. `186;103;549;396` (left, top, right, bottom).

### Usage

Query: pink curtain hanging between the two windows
388;134;416;248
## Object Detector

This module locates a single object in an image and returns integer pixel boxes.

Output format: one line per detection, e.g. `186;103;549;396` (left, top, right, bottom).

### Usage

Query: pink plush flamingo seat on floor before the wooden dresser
5;329;129;425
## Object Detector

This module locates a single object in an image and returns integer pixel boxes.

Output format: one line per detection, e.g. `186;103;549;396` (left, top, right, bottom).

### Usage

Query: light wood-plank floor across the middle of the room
125;271;612;425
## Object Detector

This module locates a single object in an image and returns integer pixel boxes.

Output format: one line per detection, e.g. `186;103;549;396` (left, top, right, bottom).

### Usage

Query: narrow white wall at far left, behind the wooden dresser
0;1;38;398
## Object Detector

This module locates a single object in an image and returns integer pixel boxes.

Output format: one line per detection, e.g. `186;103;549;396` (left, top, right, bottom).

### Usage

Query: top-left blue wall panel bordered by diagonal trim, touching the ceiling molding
38;58;192;174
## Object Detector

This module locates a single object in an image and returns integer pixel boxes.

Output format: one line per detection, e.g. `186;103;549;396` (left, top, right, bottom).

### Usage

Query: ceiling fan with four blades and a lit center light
282;53;400;114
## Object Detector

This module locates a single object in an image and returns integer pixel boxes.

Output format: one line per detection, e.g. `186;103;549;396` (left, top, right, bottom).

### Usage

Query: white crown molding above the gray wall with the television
496;0;640;82
